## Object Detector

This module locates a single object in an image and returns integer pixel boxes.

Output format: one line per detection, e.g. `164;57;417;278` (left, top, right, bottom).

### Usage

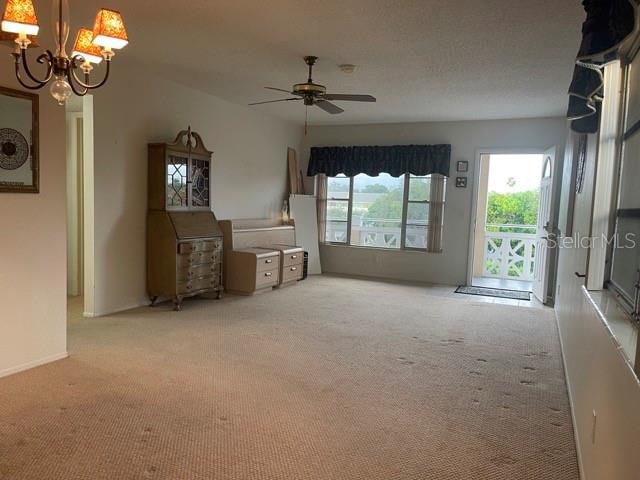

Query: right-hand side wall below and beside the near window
556;135;640;480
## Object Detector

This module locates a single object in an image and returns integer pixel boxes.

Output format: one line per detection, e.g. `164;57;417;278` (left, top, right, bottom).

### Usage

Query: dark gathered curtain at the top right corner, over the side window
567;0;636;133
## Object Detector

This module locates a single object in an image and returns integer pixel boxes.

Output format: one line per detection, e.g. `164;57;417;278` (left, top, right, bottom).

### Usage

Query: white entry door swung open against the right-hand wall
533;147;556;303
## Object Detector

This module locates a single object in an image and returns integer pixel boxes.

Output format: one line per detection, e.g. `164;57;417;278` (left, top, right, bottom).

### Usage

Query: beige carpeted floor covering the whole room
0;277;578;480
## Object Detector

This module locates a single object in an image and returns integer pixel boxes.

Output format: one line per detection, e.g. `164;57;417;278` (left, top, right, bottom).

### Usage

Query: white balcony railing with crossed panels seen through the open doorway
482;225;536;281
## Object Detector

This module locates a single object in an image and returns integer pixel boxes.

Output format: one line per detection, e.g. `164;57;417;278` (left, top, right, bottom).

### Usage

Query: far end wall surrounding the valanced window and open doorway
301;118;566;285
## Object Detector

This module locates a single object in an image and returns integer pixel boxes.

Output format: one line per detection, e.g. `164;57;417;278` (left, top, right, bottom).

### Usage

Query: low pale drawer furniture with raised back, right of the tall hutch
220;220;303;295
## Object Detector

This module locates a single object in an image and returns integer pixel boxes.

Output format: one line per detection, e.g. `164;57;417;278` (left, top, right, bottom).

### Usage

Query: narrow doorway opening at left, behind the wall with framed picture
65;96;94;321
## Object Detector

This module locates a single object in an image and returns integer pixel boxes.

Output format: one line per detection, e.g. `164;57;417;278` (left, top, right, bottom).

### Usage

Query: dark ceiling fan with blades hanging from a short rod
249;56;376;115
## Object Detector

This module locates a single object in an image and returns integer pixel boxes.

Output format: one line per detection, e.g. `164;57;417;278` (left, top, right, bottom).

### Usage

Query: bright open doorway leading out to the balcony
468;152;553;301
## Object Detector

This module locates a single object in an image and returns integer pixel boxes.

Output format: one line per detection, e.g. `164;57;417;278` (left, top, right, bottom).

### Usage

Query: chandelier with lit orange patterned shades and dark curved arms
1;0;129;105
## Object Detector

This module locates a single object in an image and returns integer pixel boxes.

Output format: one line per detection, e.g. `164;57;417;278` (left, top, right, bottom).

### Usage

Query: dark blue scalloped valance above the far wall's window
307;145;451;177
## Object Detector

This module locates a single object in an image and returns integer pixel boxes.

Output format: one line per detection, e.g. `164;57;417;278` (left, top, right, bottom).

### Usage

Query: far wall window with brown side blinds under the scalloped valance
325;173;445;252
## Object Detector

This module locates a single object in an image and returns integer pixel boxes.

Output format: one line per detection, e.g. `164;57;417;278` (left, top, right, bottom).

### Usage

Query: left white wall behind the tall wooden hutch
92;65;303;315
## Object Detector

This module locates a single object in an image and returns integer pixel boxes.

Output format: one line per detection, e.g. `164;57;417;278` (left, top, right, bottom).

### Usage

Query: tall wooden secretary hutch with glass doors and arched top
147;128;223;310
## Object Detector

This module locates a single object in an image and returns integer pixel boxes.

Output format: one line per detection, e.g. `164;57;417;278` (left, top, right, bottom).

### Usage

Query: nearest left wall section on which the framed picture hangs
0;69;67;376
